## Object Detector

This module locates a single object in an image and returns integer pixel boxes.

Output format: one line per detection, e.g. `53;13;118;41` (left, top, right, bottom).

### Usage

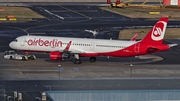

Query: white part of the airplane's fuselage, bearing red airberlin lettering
9;36;136;53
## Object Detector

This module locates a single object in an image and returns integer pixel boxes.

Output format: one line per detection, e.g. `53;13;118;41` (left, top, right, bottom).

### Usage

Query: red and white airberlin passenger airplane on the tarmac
9;17;177;64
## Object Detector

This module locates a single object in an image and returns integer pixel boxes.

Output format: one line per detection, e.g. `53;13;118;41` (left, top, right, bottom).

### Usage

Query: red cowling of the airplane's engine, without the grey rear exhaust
49;51;63;60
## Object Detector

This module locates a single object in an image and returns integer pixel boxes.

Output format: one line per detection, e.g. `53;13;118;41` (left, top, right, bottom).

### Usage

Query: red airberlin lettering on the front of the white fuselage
27;38;62;47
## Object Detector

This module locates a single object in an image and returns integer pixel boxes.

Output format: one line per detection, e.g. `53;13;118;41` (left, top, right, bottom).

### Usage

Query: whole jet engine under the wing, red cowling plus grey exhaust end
49;51;70;60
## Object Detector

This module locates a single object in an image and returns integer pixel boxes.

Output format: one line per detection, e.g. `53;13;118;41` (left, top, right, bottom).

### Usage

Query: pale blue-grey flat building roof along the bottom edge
47;90;180;101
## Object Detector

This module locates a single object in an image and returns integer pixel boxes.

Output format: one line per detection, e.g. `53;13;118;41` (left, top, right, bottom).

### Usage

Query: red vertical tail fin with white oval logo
141;17;168;44
